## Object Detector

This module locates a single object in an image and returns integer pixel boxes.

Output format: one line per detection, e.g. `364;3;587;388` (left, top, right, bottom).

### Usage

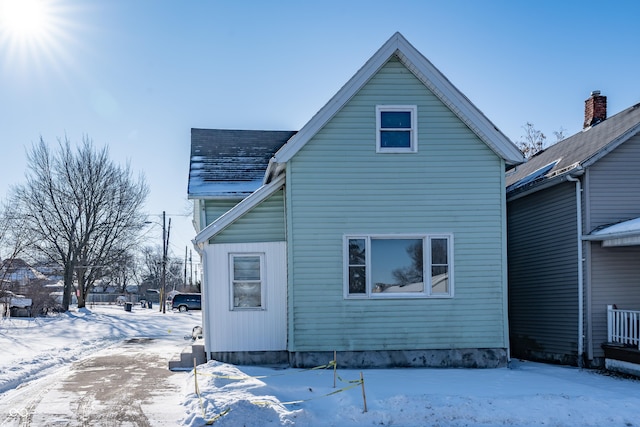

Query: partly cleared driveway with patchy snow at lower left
0;338;189;427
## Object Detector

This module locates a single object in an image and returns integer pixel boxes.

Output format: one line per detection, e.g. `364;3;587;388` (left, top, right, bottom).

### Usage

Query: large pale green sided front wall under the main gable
287;56;507;351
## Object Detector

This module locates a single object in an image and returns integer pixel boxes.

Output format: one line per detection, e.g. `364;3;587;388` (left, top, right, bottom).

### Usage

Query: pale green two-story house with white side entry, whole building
188;33;523;367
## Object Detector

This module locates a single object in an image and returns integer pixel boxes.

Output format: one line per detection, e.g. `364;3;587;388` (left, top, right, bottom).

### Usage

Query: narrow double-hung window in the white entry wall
229;254;264;310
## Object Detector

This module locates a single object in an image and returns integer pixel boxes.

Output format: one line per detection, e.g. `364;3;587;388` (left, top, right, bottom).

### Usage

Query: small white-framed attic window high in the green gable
376;105;418;153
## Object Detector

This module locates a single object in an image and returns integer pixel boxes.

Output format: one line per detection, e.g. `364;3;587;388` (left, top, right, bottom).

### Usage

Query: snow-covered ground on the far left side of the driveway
0;305;201;393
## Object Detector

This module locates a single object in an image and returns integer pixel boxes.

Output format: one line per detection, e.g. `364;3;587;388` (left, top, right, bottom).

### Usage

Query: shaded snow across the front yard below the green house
183;361;640;427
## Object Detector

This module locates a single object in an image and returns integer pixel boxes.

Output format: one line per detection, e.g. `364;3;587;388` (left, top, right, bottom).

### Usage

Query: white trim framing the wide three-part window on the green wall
342;233;455;300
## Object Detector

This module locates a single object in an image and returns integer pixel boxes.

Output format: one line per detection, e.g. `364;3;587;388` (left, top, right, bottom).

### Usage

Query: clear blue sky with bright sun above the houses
0;0;640;256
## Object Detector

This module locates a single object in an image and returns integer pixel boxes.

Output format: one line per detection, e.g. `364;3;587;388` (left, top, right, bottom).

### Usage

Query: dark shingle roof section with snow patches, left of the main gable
187;129;296;198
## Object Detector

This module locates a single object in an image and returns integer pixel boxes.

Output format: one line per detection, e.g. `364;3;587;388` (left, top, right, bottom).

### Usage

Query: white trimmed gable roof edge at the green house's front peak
265;32;524;180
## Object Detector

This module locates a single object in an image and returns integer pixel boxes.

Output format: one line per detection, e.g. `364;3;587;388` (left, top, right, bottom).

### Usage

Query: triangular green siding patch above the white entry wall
210;190;285;243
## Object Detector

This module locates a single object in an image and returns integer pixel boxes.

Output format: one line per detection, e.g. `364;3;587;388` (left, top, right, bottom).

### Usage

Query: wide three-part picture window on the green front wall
345;234;453;298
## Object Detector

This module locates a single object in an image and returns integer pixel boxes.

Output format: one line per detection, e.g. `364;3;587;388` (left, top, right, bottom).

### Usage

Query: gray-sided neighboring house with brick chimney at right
507;91;640;367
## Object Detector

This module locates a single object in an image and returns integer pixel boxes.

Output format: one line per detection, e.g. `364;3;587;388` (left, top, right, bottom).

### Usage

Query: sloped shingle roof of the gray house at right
506;104;640;196
